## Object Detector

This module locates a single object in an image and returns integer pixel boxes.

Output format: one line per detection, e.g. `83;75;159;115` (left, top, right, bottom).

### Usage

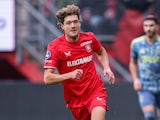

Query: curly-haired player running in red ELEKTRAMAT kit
44;5;115;120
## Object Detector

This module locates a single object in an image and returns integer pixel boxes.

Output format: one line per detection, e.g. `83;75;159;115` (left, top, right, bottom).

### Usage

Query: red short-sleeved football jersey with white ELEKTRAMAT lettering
44;32;103;107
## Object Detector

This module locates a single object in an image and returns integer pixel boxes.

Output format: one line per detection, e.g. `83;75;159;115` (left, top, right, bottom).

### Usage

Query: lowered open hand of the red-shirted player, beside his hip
103;69;115;84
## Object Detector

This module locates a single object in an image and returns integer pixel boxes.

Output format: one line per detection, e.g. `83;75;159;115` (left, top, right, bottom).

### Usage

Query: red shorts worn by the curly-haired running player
70;89;108;120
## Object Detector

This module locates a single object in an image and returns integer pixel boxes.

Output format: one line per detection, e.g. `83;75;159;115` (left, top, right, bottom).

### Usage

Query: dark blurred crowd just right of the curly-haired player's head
79;0;125;34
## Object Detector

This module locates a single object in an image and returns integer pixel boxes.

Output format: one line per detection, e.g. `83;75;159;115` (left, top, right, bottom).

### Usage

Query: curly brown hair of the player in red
56;4;80;24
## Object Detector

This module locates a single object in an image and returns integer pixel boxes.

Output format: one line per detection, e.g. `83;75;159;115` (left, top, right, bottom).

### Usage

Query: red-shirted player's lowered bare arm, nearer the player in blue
96;47;115;84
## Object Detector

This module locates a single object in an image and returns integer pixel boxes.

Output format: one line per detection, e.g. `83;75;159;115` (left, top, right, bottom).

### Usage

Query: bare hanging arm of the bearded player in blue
129;59;141;91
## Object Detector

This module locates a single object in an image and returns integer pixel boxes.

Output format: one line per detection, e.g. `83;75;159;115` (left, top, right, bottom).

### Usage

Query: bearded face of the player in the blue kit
143;20;158;38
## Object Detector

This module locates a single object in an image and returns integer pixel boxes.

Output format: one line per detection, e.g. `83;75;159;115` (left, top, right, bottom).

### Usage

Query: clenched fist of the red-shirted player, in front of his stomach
70;69;83;79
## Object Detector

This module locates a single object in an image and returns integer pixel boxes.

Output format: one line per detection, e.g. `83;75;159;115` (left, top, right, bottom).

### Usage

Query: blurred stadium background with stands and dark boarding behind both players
0;0;160;120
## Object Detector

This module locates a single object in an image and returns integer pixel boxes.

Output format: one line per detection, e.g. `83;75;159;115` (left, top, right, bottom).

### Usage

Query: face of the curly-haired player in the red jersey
61;15;81;41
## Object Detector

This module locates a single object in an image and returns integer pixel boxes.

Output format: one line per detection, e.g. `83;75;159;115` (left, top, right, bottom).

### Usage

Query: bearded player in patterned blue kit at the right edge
130;15;160;120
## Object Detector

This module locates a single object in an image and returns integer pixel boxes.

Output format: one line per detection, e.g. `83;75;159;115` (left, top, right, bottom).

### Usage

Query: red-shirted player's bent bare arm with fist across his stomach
44;69;83;85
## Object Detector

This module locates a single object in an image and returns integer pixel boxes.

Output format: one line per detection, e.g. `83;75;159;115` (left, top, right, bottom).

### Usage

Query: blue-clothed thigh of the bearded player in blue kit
138;91;155;108
